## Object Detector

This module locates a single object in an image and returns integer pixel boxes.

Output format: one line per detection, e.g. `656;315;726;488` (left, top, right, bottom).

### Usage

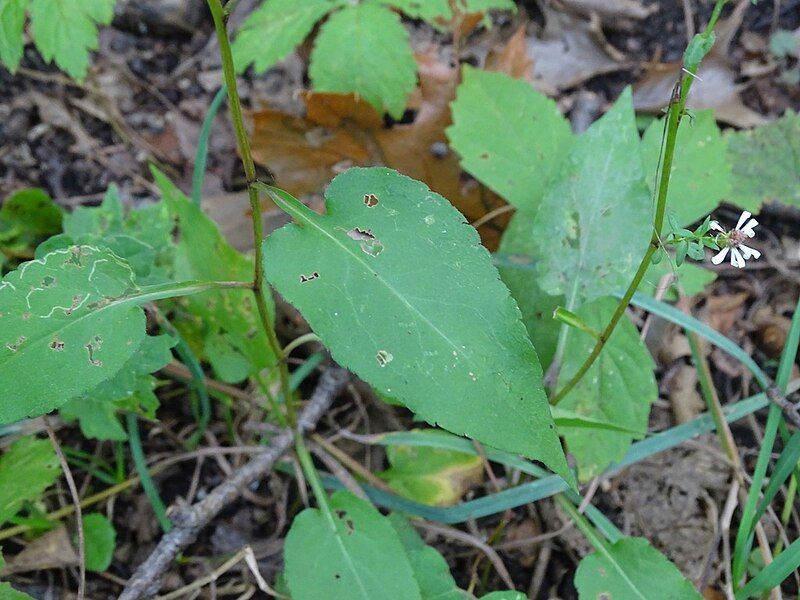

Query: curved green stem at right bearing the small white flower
550;0;727;405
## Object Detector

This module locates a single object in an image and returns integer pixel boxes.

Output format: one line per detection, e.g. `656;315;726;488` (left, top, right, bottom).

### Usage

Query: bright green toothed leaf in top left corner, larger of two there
30;0;114;80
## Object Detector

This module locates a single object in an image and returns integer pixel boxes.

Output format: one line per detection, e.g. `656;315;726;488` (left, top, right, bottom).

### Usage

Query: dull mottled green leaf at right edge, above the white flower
728;110;800;213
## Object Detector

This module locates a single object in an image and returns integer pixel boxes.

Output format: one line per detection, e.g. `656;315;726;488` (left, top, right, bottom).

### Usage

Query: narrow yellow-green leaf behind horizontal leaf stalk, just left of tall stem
153;169;276;383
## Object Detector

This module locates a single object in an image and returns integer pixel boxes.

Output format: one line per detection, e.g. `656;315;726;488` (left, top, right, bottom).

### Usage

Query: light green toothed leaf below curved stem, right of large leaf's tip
558;298;658;481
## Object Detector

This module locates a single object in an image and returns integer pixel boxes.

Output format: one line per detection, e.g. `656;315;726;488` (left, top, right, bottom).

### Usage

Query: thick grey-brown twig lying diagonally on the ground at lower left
119;368;348;600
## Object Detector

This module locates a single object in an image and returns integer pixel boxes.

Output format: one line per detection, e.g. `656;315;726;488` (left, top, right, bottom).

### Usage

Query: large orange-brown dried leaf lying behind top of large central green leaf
250;55;518;248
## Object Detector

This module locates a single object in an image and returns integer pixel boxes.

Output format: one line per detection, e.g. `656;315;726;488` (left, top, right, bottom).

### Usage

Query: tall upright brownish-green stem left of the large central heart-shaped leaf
208;0;297;425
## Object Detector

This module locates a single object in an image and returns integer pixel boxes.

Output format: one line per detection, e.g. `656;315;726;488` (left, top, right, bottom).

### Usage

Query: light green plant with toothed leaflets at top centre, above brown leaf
233;0;516;119
